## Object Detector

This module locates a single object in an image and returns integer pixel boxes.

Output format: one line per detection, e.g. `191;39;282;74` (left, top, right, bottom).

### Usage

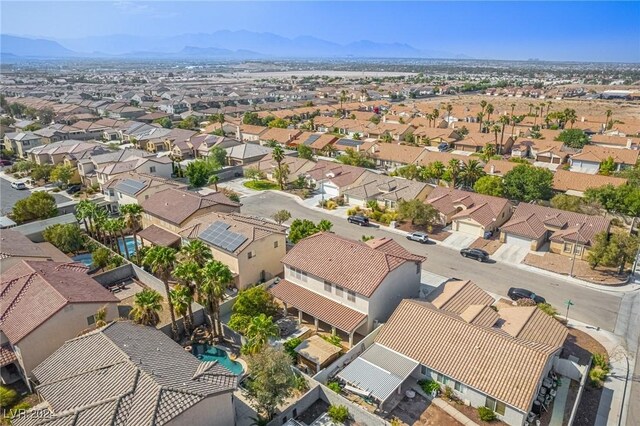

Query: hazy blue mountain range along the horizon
0;30;469;59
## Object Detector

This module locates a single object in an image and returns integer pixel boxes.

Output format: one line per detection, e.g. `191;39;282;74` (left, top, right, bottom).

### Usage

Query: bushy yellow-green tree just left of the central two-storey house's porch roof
229;286;278;334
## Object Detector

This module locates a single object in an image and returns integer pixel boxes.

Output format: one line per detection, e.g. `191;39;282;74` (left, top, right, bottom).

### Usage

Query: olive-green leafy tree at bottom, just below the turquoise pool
247;346;295;419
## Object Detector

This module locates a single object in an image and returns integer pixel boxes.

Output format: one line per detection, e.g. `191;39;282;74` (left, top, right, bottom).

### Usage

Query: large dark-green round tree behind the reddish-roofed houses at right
504;164;553;203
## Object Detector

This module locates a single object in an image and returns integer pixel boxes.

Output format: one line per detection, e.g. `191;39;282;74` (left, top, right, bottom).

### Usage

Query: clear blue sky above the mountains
0;0;640;62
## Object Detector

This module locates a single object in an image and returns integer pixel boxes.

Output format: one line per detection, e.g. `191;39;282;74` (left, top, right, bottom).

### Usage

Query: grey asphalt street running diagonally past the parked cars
241;192;626;331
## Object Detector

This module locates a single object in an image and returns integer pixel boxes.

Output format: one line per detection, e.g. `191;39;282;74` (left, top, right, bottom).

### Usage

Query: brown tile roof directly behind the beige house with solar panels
142;188;240;225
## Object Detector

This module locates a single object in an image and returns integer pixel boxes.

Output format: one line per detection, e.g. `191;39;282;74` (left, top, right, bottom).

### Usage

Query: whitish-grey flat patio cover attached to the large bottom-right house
338;343;418;403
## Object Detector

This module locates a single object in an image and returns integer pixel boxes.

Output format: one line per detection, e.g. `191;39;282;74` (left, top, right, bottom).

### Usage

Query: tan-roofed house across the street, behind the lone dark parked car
342;170;433;209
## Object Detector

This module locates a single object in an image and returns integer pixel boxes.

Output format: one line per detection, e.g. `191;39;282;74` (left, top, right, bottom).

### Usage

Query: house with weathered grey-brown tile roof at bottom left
13;321;238;426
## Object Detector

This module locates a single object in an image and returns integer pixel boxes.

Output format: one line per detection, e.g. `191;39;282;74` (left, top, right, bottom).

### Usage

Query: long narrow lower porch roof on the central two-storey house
269;280;367;333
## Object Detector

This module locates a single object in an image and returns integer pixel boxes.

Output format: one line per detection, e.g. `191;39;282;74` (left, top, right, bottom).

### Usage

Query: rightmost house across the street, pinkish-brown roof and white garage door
500;203;611;259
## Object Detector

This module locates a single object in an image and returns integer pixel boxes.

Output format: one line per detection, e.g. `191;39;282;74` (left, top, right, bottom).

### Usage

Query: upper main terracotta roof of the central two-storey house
282;232;425;297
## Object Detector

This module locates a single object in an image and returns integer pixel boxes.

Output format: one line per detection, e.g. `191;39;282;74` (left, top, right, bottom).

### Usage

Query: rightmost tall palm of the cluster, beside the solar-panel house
200;260;233;338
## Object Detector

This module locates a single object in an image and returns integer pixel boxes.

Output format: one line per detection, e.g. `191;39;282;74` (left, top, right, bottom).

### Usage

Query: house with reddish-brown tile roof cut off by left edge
0;260;118;383
